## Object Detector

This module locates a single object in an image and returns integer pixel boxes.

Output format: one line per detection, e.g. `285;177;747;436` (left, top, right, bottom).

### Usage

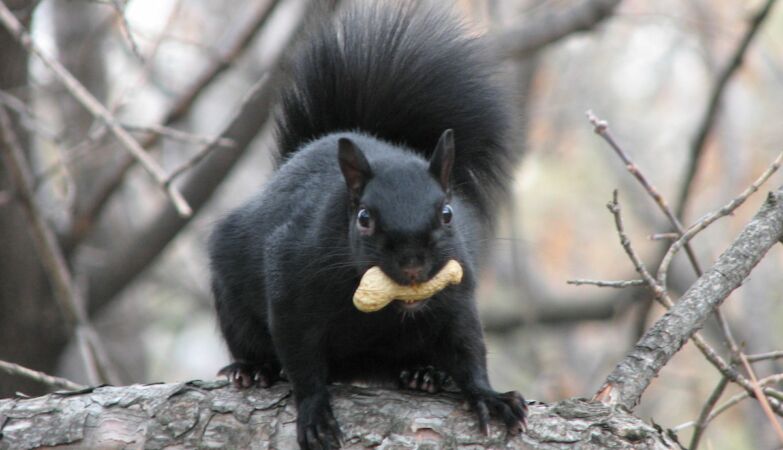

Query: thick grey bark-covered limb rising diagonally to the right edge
597;188;783;408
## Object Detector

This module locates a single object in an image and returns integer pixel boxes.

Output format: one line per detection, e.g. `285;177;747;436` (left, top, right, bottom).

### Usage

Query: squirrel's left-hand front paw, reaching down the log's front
296;394;342;450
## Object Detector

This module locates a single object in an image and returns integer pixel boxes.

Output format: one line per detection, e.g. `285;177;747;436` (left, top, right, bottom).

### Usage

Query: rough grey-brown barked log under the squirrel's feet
0;381;681;450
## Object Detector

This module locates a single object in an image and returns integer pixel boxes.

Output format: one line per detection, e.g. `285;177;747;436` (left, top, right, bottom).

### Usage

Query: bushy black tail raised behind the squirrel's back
278;1;514;219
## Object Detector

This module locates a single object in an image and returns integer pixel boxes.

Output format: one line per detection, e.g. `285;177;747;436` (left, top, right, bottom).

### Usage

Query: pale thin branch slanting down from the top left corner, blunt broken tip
0;1;192;217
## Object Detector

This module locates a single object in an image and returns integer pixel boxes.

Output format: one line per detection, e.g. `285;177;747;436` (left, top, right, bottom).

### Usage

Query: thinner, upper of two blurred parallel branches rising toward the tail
63;0;280;251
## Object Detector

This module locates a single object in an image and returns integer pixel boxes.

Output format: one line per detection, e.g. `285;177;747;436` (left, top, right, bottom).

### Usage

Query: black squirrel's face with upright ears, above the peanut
339;131;459;285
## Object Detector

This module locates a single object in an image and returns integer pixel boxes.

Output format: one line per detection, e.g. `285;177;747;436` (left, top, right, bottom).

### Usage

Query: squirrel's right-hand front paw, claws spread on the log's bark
469;391;527;435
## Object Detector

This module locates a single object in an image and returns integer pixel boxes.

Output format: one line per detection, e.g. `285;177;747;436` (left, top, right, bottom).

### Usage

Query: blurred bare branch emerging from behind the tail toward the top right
494;0;620;58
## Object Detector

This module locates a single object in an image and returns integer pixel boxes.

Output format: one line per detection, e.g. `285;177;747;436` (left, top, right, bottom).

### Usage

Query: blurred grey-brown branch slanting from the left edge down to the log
0;104;116;382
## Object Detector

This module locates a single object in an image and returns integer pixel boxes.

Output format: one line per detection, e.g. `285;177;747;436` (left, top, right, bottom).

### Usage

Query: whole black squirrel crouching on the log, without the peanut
209;1;527;449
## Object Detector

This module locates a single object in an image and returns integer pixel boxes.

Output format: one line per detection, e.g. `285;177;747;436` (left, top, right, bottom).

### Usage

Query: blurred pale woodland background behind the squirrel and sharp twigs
0;0;783;449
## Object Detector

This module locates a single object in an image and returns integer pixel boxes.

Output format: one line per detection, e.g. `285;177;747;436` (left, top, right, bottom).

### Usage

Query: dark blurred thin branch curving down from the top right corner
676;0;775;219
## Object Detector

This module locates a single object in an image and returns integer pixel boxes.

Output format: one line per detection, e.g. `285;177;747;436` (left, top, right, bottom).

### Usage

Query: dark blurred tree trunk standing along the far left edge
0;0;66;397
